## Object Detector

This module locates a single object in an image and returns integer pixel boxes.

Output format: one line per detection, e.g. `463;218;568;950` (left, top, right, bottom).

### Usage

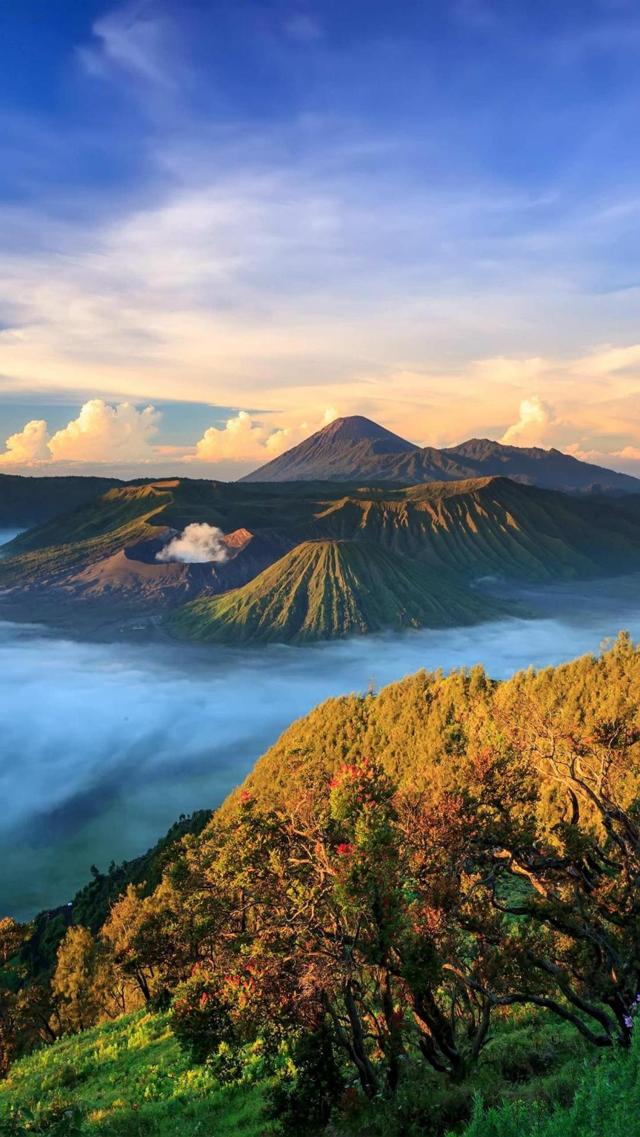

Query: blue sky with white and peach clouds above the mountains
0;0;640;479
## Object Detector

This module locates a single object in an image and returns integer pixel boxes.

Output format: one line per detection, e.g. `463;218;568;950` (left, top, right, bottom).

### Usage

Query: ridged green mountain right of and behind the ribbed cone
316;478;640;581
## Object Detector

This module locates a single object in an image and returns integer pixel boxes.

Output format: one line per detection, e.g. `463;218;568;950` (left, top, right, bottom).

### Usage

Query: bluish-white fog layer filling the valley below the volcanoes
0;578;640;919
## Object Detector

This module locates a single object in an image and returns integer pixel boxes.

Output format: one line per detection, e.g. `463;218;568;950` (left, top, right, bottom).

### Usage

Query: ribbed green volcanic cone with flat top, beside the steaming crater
168;540;506;644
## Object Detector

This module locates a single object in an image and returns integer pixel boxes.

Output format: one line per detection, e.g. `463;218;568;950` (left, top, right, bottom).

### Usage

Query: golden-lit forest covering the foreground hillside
0;633;640;1137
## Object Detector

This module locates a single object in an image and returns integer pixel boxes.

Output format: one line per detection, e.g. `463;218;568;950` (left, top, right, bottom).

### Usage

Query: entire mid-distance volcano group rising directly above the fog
0;478;640;644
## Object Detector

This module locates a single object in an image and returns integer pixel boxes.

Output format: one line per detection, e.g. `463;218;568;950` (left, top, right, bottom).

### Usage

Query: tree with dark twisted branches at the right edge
468;709;640;1046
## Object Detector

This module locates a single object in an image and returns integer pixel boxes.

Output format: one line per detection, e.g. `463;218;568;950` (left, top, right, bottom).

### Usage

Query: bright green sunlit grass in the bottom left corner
0;1012;269;1137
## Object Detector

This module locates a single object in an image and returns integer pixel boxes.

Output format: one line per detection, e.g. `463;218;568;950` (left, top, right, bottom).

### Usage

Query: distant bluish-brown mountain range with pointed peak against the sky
243;415;640;493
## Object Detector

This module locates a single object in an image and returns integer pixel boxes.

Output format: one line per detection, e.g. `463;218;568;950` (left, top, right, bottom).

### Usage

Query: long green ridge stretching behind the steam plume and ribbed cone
5;478;640;587
